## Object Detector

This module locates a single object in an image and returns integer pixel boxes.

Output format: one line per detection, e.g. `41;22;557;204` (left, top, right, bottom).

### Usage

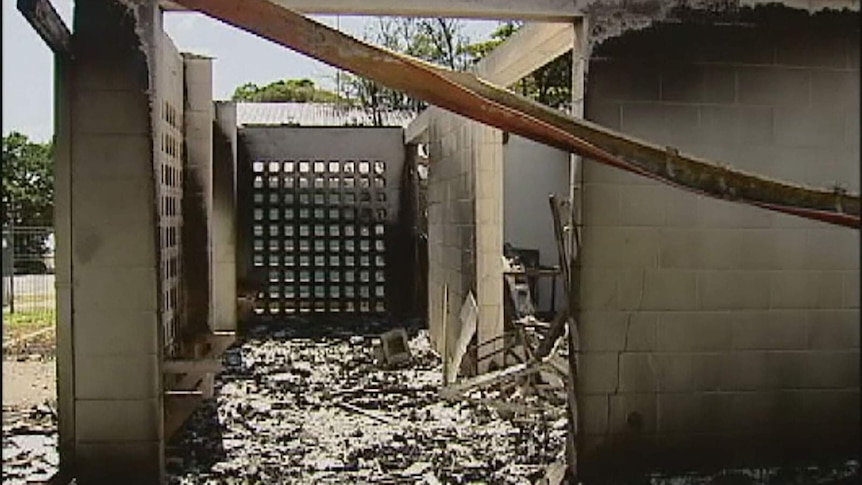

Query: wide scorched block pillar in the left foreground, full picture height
68;0;164;483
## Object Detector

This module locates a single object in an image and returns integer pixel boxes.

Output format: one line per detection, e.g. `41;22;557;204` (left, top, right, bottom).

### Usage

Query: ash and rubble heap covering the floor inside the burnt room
167;324;566;483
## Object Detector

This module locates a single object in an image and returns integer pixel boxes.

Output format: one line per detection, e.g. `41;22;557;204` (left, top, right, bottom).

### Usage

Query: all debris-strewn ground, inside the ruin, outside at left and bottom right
3;314;860;485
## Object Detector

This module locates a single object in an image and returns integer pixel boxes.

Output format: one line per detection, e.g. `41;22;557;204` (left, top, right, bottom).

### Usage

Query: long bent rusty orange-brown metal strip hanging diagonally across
172;0;860;229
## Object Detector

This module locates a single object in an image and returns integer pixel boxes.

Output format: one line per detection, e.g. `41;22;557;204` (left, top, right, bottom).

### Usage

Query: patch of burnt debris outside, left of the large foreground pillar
3;404;60;485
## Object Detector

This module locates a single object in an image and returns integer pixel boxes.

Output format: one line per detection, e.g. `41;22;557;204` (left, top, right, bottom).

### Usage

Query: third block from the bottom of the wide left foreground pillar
75;352;161;400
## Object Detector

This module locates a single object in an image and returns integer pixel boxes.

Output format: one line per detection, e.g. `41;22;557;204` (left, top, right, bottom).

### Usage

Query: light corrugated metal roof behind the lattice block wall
236;103;416;127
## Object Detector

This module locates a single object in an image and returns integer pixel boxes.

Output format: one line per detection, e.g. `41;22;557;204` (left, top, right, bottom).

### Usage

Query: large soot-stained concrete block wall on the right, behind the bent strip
578;8;860;476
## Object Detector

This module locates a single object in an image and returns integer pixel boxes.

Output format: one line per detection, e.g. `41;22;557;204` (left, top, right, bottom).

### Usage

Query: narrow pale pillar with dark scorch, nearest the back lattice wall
212;103;237;331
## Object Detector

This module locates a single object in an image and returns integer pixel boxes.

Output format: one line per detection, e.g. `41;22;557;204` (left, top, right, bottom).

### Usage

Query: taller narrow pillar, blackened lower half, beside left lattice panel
183;54;214;335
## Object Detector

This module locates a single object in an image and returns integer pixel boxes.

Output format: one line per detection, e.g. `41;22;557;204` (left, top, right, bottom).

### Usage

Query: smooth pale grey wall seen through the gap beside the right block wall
503;135;570;309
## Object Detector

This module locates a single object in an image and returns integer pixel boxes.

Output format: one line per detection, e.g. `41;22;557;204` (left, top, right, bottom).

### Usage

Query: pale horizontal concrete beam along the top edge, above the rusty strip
161;0;581;21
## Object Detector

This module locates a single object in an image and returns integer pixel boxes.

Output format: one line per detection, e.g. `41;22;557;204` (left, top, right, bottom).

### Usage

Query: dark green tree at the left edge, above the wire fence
2;132;54;226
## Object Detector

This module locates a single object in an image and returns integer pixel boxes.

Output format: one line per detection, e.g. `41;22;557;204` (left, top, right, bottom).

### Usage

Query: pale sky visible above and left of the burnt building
0;0;496;141
